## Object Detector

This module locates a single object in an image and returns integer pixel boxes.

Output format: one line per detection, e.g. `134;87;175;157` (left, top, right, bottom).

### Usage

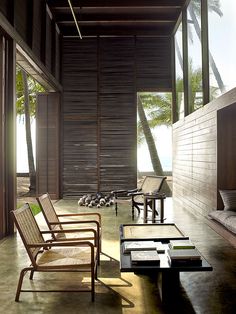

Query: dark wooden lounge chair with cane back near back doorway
112;176;166;219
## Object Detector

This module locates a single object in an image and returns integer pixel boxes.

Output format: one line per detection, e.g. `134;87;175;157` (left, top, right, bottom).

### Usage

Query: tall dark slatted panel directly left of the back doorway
99;38;137;191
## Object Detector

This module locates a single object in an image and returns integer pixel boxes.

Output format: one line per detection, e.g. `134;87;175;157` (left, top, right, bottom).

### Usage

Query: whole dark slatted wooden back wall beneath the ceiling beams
62;37;171;197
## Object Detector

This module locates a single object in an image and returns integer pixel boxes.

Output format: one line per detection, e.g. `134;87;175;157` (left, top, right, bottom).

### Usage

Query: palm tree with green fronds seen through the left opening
16;67;44;195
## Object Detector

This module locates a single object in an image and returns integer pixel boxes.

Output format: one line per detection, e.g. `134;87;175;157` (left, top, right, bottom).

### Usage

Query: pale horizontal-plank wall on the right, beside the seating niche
173;89;236;216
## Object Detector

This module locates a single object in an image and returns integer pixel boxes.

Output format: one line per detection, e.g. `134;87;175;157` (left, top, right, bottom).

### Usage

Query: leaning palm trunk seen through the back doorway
138;96;171;196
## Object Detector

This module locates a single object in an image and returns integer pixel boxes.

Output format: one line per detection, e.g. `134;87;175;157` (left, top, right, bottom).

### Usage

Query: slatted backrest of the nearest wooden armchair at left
11;203;45;265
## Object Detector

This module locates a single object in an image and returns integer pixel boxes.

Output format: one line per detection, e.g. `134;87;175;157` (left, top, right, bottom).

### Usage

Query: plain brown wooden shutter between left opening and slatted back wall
36;93;60;199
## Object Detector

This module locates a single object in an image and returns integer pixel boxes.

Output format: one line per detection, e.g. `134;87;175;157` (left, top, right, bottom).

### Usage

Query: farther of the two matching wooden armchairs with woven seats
36;193;102;262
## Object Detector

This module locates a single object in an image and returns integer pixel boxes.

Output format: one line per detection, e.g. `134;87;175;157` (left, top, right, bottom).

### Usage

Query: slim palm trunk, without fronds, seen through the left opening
21;70;36;195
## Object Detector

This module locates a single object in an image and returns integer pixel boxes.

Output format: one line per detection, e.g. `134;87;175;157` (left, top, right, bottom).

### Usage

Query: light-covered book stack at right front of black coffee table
167;249;202;265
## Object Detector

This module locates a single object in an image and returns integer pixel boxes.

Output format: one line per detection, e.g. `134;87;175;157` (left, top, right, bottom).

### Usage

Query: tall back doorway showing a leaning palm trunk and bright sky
137;92;172;195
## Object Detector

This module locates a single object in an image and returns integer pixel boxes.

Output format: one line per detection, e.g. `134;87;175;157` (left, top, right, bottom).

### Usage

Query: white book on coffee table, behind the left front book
123;241;165;253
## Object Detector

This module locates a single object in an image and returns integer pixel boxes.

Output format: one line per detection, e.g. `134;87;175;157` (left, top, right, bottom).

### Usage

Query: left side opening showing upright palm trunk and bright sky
16;64;45;197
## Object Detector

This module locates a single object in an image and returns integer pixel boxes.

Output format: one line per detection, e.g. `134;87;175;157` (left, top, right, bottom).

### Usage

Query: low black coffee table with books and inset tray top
120;224;213;303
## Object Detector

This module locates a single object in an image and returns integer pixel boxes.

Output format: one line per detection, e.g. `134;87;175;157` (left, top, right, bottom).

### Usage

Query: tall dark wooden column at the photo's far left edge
0;34;16;238
